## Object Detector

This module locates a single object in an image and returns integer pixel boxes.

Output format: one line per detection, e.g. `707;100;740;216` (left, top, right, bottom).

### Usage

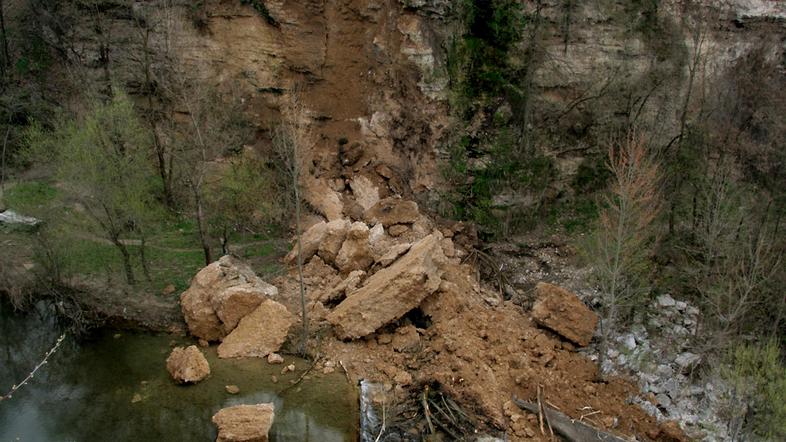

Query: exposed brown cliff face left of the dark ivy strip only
39;0;450;219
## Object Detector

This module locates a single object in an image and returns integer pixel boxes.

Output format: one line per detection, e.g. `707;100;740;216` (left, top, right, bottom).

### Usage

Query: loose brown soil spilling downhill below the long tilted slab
275;258;684;440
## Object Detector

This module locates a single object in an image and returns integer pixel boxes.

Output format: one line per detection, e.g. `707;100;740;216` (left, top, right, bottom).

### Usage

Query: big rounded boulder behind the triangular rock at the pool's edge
180;256;278;341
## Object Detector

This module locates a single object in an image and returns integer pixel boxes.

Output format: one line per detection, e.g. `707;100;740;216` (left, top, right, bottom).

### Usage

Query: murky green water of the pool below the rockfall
0;303;359;442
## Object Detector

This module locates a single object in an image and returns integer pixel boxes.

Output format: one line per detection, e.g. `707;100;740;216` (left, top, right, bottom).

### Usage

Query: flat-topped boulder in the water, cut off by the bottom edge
213;404;275;442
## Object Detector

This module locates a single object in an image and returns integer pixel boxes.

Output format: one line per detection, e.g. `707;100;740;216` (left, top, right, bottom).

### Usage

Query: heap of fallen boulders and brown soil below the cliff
274;191;682;440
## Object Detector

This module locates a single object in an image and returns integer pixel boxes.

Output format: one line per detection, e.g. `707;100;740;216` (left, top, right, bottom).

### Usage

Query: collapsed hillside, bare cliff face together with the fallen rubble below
3;0;783;439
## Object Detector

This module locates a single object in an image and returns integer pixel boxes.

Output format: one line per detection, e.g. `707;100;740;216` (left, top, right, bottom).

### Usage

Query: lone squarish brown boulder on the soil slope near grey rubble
532;282;598;347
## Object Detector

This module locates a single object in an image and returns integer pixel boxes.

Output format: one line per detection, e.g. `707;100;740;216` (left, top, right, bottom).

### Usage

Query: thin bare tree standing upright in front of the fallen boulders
273;90;313;354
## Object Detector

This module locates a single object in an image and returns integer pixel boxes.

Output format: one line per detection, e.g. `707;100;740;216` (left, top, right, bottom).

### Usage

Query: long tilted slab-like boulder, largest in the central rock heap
327;232;447;339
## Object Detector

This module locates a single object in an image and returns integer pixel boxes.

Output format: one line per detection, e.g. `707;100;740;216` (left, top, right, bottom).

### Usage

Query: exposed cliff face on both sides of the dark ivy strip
38;0;786;219
